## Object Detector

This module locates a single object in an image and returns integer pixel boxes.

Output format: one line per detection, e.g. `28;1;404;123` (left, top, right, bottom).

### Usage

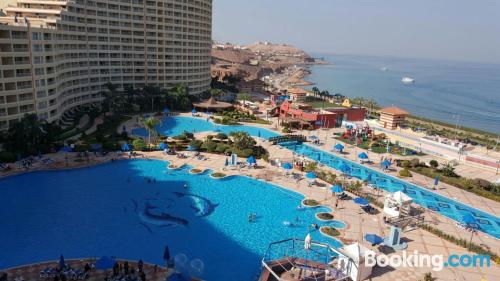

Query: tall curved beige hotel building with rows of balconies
0;0;212;130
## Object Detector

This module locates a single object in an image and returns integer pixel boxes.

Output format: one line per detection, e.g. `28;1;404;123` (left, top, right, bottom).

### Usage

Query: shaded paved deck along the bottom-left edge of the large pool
0;259;172;281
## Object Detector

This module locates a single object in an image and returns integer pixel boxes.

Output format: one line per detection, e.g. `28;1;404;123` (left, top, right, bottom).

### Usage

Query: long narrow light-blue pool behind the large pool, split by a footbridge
132;117;500;238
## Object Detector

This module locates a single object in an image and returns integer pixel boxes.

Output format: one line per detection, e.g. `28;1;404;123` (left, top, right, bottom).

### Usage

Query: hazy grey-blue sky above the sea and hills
213;0;500;64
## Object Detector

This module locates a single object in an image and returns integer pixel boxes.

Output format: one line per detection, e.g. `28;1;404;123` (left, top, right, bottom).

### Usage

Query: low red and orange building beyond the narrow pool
279;100;365;129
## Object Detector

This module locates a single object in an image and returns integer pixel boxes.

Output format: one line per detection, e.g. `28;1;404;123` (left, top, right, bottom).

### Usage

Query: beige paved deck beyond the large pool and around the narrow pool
0;112;500;281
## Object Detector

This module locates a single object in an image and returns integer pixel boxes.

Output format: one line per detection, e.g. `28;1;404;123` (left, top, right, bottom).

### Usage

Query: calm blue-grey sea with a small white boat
306;54;500;134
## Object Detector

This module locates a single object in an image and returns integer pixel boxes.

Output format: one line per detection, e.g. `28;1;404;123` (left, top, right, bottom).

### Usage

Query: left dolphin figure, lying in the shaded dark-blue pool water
132;199;189;227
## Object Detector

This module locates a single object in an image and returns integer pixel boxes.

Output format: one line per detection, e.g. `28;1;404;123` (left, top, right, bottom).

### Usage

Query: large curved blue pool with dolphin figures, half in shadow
0;160;344;281
